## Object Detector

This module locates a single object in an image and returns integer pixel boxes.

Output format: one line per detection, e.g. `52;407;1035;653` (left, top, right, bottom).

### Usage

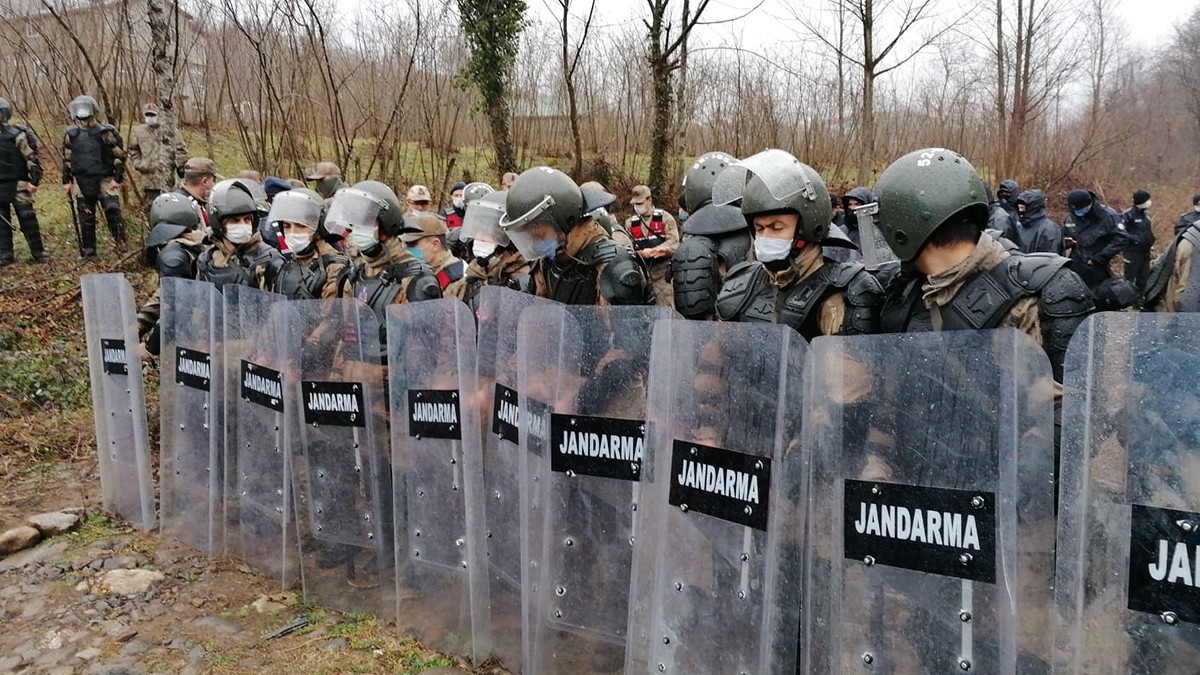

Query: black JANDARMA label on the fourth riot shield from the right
550;413;646;480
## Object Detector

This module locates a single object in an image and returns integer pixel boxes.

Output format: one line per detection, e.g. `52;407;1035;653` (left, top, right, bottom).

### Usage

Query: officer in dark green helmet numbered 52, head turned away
876;148;1092;382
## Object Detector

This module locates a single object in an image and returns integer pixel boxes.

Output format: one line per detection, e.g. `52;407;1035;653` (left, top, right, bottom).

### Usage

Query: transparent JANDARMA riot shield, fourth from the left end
283;299;395;616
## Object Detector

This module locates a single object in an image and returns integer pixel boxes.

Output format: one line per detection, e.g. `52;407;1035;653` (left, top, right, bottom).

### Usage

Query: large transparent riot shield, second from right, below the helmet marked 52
800;329;1055;674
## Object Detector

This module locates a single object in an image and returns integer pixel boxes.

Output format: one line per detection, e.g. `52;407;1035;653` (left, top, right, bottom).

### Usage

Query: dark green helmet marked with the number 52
875;148;988;261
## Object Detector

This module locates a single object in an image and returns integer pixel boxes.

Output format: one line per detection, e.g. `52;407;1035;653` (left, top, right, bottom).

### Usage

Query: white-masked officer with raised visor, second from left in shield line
196;180;291;292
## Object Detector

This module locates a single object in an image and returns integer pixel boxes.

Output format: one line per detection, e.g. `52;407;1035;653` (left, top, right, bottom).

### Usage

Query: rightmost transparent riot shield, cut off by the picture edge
1055;312;1200;674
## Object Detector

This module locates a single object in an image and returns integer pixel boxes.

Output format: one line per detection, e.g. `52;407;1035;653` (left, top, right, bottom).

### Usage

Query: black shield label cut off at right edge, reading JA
1129;504;1200;623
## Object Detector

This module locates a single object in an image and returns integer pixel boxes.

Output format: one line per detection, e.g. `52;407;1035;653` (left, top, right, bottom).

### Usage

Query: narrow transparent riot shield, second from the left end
158;277;224;556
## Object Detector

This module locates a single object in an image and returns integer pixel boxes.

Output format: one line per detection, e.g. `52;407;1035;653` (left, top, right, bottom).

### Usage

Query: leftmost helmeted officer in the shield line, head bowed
138;192;206;356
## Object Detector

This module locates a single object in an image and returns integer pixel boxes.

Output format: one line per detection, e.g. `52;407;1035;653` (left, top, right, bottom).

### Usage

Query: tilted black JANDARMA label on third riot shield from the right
667;440;770;531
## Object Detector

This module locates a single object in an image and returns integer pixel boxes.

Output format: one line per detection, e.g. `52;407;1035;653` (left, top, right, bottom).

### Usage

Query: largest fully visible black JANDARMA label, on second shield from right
844;480;996;584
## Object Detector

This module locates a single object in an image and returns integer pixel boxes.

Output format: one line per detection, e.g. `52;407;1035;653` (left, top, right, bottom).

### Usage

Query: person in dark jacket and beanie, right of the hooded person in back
1062;190;1128;288
